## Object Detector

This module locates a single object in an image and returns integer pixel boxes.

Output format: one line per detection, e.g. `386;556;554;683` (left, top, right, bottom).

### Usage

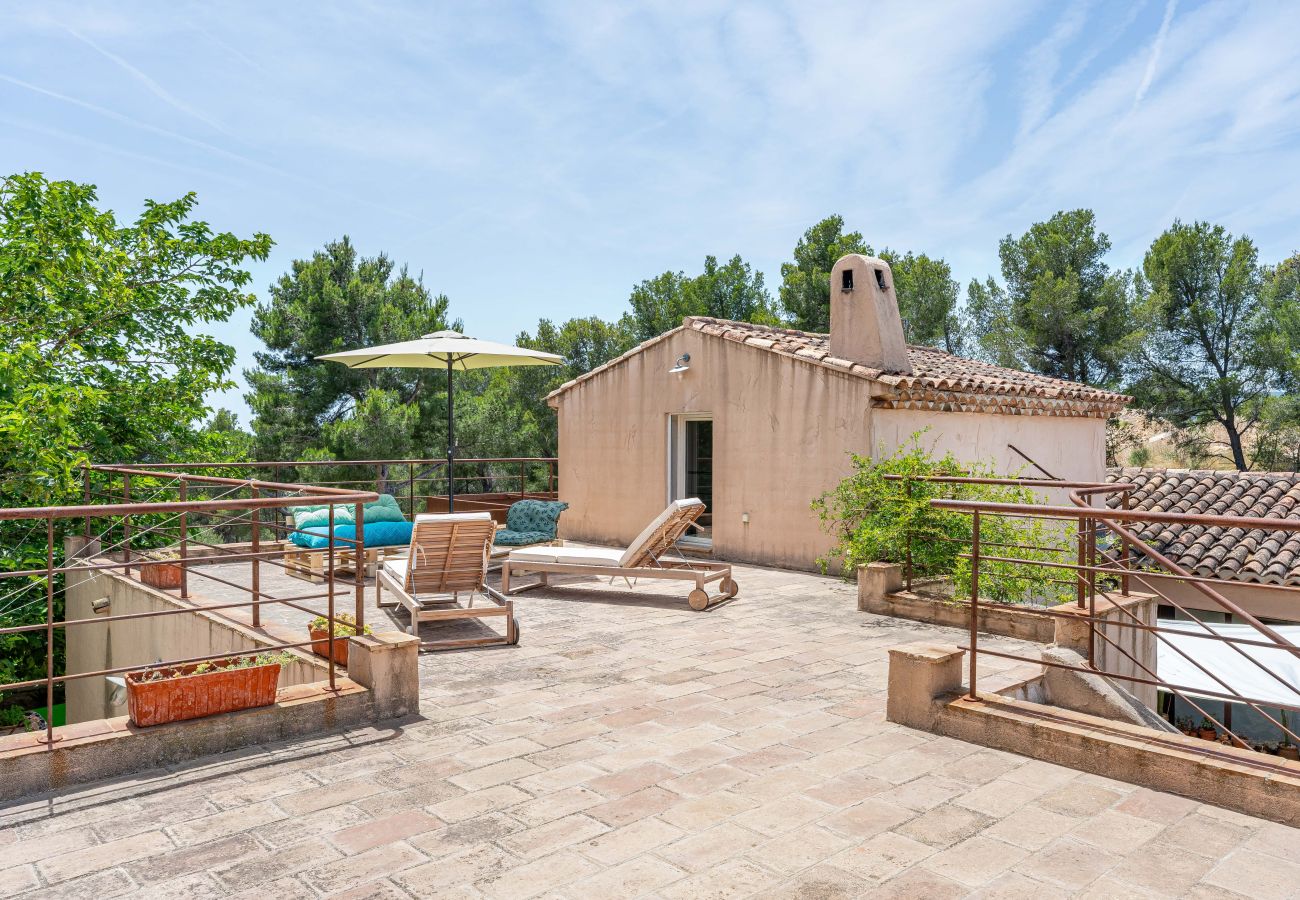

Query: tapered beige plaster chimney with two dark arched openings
831;254;911;375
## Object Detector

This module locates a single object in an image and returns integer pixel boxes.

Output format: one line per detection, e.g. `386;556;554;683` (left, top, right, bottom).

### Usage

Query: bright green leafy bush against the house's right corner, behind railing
813;432;1074;605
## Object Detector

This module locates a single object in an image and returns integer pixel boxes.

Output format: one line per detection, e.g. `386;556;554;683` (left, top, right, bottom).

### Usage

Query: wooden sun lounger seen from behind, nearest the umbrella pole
374;512;519;650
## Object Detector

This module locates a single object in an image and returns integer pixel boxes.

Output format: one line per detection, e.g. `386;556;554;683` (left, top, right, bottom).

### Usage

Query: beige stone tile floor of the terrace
0;567;1300;899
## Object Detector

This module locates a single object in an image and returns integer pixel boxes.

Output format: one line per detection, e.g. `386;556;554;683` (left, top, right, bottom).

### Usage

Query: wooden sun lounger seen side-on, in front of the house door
501;499;740;610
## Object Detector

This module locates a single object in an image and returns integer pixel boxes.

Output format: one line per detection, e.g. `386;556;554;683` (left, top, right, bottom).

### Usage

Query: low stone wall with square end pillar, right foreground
885;644;1300;827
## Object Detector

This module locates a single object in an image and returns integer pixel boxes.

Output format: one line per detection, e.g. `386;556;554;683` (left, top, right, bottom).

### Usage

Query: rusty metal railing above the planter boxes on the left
0;463;378;748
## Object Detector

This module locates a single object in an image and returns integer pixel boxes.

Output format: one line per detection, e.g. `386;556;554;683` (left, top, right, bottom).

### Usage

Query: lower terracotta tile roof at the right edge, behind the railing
1106;468;1300;585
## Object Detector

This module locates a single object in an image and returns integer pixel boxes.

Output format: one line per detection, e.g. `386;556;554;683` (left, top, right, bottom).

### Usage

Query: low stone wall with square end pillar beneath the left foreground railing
0;632;420;802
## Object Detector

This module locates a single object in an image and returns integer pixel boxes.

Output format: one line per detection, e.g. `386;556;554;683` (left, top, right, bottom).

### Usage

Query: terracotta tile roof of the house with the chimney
551;316;1131;417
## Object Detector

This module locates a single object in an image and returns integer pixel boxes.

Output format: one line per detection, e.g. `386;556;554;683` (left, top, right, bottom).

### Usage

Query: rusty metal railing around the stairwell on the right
931;489;1300;752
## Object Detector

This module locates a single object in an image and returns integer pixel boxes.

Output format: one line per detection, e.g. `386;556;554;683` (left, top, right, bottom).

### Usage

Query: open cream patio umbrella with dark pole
316;330;564;512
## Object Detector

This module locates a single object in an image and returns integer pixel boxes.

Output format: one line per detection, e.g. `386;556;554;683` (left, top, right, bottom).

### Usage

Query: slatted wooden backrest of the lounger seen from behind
406;512;497;593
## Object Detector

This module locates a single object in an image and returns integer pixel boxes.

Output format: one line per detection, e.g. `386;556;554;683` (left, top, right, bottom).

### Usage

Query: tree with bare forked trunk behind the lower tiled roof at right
1132;221;1295;470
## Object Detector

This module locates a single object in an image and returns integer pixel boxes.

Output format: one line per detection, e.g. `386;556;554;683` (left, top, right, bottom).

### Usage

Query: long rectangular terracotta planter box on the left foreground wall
126;657;280;726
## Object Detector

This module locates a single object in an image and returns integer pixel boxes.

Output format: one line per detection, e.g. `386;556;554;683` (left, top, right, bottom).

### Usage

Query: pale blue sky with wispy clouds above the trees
0;0;1300;419
